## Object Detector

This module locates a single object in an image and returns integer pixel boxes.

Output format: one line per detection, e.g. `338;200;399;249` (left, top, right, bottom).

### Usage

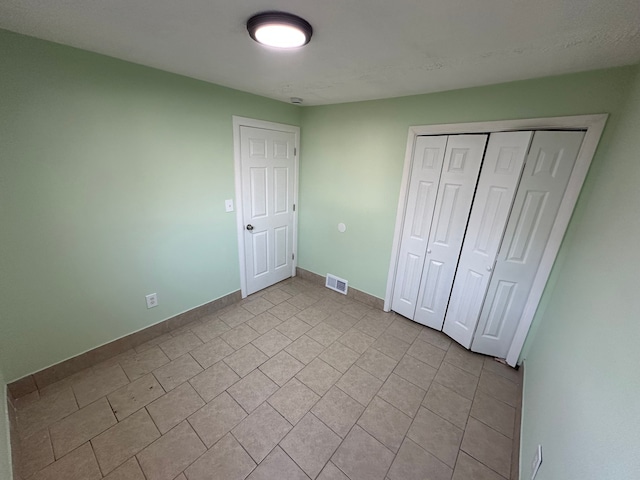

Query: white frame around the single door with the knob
232;115;300;298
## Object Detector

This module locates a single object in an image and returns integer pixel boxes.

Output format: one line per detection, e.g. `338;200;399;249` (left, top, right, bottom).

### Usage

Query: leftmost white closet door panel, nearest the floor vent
391;136;447;318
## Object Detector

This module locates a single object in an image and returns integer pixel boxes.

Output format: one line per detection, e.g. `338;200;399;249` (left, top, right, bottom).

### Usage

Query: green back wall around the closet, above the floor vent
299;67;634;298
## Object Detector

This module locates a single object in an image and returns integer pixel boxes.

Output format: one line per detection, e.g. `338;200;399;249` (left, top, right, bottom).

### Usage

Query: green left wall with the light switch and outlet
0;31;301;381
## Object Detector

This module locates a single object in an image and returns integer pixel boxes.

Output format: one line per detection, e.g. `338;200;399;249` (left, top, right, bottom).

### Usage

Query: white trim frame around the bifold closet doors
384;114;609;367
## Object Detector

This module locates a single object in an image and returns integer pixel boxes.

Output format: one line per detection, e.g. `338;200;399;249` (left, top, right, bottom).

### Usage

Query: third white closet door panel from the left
444;132;533;348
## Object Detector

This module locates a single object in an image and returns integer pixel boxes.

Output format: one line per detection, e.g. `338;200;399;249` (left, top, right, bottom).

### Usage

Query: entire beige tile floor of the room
11;279;520;480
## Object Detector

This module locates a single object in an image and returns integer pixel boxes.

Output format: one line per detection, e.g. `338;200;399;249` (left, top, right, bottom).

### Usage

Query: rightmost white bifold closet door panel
471;131;584;358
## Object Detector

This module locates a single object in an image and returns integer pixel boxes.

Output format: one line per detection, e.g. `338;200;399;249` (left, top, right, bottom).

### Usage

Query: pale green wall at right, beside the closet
522;66;640;480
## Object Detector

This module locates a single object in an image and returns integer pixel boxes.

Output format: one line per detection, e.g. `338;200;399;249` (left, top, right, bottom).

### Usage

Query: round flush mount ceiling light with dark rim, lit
247;12;313;48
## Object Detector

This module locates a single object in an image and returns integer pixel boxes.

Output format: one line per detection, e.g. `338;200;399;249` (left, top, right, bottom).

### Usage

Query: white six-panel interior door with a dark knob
240;126;296;295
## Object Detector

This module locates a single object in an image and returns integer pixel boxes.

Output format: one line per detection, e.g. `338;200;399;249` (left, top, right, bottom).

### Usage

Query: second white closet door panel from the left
414;135;488;330
